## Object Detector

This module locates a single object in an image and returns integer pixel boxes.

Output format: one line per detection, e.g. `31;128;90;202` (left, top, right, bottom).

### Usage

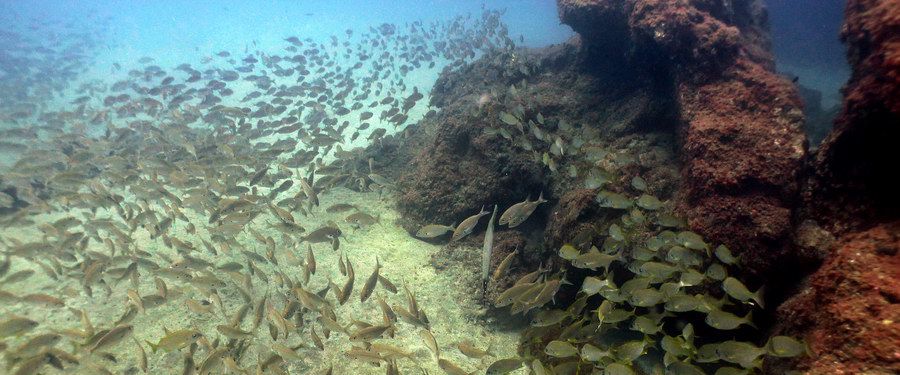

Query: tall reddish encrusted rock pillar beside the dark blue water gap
558;0;806;275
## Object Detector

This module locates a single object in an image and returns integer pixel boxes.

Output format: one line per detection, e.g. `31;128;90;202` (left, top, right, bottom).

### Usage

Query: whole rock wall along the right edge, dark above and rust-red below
776;0;900;374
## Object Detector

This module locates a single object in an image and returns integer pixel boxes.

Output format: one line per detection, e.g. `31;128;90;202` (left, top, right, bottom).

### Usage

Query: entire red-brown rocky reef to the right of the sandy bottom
360;0;900;374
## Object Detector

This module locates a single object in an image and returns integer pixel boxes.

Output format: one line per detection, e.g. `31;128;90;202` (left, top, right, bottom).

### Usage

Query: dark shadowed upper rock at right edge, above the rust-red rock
804;0;900;234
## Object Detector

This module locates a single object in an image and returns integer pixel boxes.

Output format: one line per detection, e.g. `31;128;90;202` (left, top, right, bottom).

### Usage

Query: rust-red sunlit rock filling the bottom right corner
770;221;900;374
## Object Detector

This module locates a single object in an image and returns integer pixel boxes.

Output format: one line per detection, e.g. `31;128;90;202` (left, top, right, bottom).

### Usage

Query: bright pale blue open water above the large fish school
0;0;573;75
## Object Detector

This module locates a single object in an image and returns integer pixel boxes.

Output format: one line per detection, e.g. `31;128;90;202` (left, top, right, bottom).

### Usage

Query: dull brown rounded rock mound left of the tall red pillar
396;43;673;235
